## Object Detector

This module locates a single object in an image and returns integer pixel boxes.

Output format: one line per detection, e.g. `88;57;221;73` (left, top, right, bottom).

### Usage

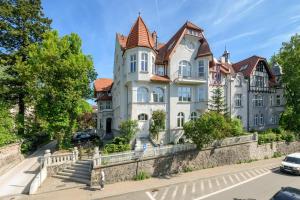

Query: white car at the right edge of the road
280;153;300;175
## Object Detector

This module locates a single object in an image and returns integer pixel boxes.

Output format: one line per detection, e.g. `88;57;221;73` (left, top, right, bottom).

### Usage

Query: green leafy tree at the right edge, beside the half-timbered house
276;34;300;131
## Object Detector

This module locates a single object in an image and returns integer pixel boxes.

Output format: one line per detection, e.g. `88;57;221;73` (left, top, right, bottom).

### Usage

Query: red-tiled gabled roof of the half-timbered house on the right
232;55;274;80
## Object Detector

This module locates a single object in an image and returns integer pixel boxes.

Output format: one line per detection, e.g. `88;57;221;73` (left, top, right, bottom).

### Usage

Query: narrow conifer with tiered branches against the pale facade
208;86;228;115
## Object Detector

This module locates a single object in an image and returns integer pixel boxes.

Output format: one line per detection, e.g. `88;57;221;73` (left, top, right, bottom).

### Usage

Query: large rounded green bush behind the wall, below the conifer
183;111;231;149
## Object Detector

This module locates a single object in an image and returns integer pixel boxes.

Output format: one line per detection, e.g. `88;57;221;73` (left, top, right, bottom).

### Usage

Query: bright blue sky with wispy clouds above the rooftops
42;0;300;101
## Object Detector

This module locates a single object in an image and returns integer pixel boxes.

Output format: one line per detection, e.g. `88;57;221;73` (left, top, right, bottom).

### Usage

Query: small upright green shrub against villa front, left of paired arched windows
149;110;166;139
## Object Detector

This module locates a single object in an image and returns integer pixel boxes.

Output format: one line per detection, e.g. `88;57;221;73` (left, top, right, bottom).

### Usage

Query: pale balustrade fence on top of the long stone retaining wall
93;133;257;167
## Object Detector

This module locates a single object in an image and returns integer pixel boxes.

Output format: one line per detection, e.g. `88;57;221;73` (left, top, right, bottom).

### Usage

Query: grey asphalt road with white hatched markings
105;165;300;200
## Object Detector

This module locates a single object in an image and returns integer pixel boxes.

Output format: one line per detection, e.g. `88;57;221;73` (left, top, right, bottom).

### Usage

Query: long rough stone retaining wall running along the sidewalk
91;142;300;186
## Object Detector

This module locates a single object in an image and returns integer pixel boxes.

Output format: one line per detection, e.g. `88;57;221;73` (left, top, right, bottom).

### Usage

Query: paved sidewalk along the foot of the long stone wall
22;157;283;200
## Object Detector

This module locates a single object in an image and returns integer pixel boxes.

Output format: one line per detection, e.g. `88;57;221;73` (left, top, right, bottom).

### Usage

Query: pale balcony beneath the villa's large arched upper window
175;71;207;84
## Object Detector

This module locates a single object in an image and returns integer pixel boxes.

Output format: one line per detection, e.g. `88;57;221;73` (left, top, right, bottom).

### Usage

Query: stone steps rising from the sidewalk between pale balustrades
53;160;92;185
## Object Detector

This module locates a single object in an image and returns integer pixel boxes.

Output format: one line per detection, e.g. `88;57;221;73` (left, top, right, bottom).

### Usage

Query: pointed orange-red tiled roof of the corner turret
126;16;154;49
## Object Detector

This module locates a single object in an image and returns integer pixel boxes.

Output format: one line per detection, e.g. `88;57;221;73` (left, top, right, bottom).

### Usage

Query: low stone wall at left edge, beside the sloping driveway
0;143;24;175
